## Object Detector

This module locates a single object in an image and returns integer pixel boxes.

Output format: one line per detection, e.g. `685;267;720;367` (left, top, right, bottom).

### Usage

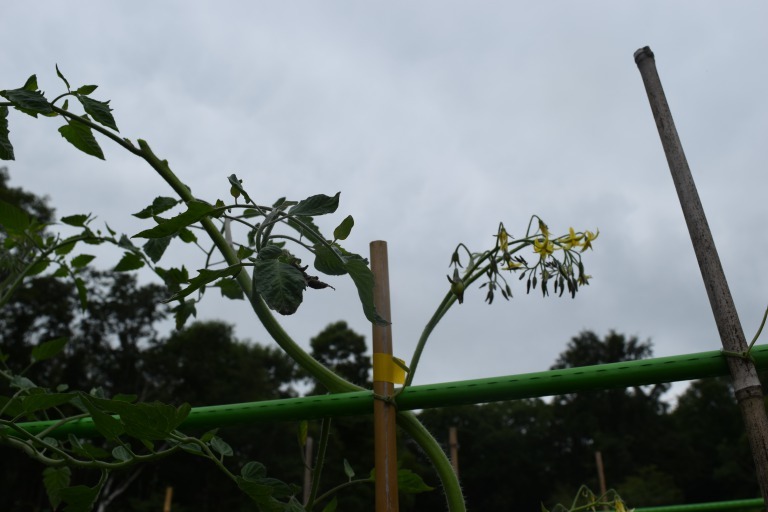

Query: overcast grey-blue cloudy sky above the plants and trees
0;0;768;398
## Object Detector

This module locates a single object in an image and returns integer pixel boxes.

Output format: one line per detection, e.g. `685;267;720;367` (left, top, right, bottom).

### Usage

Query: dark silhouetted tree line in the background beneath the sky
0;167;759;512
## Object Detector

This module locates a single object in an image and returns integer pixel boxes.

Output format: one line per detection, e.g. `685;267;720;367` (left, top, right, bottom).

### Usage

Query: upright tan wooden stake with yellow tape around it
371;240;399;512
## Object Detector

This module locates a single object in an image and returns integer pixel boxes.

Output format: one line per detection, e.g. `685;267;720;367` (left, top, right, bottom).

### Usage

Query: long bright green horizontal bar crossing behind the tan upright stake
12;345;768;436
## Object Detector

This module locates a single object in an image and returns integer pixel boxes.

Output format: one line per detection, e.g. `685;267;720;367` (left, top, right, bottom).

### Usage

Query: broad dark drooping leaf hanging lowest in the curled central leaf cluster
253;259;307;315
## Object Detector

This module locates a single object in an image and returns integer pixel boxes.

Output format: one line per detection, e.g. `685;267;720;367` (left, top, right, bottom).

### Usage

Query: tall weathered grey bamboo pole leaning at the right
635;46;768;503
